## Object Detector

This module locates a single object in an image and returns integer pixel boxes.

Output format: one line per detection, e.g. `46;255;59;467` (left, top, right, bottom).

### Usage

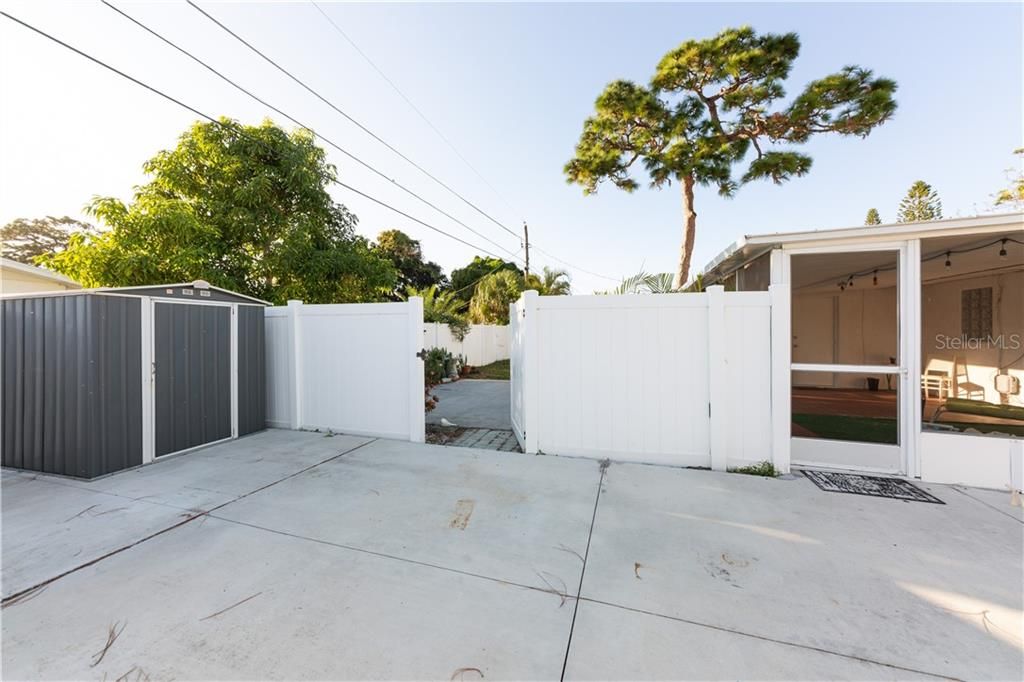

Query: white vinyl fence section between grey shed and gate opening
265;297;424;442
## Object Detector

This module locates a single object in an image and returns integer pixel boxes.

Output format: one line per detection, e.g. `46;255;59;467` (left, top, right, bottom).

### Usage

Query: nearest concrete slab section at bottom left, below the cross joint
3;518;572;680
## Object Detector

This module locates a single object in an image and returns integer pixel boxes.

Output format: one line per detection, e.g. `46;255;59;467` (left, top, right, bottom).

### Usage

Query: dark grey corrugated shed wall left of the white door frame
0;295;142;478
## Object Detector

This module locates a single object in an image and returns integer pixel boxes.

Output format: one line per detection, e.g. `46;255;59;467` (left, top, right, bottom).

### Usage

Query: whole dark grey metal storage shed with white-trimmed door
0;281;267;478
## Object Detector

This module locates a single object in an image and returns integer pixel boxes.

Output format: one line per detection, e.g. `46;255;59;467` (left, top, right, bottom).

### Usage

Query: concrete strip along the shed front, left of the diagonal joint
2;431;372;598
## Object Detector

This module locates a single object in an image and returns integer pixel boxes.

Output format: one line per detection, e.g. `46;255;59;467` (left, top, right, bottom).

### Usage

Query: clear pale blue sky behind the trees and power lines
0;0;1024;293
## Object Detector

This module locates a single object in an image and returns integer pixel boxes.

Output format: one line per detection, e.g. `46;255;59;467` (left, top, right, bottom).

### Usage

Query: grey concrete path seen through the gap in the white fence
427;379;512;431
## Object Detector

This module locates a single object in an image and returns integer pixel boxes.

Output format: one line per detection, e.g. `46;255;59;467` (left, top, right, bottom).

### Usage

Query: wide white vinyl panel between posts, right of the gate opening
526;294;710;466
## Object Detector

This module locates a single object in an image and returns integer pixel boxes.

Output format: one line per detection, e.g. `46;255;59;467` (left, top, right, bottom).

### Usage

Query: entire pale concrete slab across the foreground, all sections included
2;431;1024;680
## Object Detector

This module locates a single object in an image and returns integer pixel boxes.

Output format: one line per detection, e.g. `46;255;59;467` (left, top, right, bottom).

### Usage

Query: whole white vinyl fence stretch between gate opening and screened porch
511;287;772;470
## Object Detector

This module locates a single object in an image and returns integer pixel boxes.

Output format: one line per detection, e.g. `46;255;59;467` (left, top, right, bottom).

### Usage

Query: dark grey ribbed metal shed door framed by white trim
153;301;232;457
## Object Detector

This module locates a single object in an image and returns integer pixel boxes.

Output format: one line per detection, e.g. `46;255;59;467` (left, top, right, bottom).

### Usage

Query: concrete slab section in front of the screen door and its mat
573;464;1024;679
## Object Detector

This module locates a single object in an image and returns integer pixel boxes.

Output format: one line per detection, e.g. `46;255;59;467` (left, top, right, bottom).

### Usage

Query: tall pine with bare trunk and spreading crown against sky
564;27;896;289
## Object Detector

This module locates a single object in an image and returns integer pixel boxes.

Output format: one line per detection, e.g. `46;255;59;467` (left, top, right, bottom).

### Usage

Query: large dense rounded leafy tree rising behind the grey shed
41;119;395;303
